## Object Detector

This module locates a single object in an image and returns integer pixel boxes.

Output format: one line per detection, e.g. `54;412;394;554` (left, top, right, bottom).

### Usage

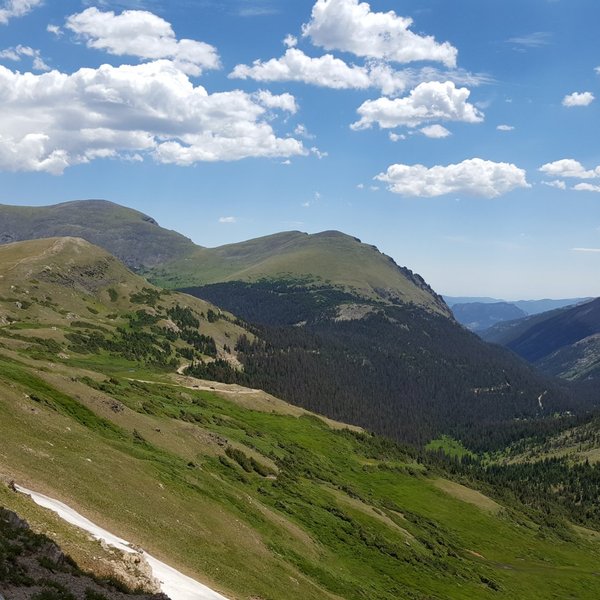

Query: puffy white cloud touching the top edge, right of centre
302;0;457;67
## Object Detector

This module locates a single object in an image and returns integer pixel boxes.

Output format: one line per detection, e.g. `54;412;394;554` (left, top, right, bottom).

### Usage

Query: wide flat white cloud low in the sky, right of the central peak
375;158;531;198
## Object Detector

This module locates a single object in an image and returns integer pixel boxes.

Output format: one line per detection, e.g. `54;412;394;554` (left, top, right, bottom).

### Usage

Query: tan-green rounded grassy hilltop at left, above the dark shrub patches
0;238;244;367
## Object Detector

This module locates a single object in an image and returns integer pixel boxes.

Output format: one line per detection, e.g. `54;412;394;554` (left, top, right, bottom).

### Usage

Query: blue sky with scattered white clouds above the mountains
0;0;600;300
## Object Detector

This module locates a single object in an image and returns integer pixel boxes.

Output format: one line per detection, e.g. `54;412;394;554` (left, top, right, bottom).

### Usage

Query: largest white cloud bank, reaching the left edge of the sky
0;60;307;174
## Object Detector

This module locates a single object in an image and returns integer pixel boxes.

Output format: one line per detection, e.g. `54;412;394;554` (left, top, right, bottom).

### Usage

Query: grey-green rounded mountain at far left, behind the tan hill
0;200;196;269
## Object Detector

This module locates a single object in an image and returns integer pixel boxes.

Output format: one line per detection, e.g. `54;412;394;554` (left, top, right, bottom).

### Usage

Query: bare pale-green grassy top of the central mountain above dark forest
146;231;449;314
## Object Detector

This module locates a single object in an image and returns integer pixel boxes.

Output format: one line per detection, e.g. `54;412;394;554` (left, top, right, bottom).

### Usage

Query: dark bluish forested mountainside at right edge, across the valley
483;298;600;380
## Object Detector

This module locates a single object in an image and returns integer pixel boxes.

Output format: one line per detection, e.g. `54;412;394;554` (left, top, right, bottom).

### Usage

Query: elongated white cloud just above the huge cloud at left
65;7;220;75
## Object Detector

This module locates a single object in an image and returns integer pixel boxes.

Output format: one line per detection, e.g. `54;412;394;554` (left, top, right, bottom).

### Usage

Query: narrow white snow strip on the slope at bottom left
15;485;227;600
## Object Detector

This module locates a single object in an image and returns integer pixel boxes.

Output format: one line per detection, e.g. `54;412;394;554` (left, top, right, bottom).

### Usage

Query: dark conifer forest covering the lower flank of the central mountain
183;282;595;449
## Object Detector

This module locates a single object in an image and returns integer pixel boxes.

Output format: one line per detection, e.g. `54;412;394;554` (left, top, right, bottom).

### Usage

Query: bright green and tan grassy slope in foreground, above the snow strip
0;354;599;599
